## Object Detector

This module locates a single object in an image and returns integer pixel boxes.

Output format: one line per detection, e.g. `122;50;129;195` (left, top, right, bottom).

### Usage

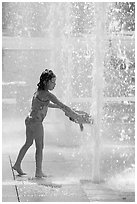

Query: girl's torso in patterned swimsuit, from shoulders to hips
27;91;49;122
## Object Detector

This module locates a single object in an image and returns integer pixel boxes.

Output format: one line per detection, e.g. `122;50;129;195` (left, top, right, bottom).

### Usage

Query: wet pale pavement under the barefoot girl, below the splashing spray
2;146;135;202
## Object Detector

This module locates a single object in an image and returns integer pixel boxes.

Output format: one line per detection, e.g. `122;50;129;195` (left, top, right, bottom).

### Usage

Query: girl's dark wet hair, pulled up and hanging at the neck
37;69;56;90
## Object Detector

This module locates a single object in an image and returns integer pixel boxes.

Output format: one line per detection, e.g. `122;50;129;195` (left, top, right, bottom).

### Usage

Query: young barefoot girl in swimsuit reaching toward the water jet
12;69;91;178
